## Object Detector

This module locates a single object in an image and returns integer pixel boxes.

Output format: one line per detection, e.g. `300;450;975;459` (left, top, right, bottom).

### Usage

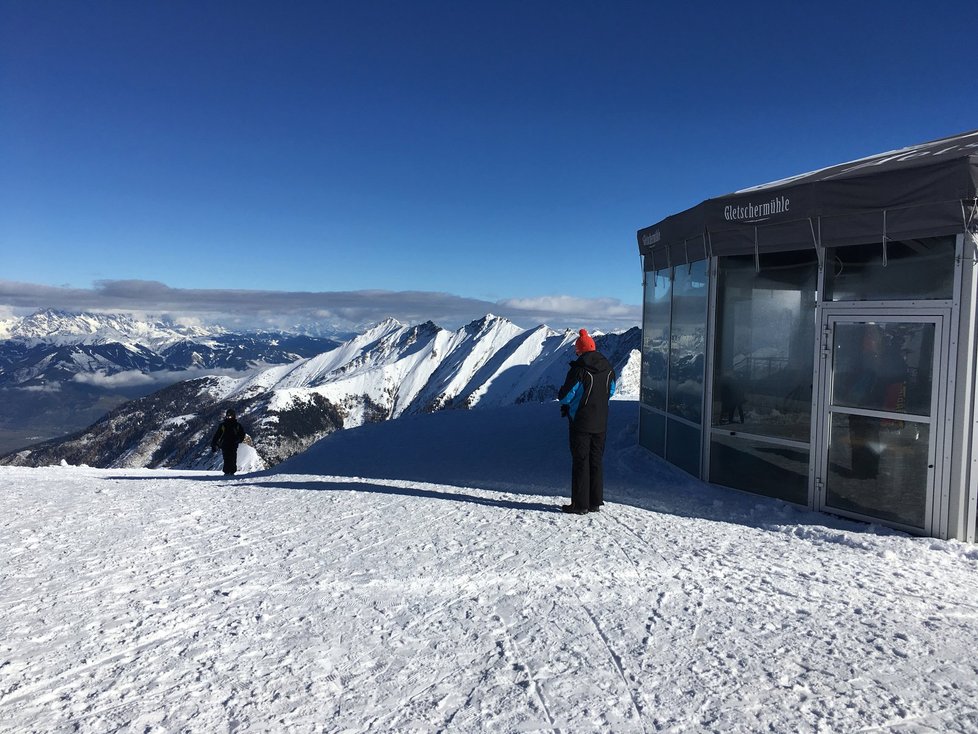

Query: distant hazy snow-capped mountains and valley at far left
0;310;339;452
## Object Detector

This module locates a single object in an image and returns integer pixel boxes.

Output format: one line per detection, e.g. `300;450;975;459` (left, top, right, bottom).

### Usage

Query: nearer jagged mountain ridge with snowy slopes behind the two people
0;314;641;468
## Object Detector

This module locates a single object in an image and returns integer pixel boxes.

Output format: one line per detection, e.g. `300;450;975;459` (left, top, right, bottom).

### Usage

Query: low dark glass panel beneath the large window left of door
710;432;808;504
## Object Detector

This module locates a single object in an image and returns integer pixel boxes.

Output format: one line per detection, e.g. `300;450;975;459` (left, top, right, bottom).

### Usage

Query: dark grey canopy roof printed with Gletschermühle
638;130;978;270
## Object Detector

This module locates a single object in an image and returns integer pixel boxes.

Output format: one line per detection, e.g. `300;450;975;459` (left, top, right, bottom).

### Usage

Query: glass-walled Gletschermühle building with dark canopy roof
638;131;978;542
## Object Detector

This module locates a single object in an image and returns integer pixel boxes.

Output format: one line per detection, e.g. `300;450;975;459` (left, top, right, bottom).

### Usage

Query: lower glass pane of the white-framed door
825;413;930;528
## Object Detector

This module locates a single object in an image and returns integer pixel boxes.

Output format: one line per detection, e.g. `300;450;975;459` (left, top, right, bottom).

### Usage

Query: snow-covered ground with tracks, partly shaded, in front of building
0;402;978;733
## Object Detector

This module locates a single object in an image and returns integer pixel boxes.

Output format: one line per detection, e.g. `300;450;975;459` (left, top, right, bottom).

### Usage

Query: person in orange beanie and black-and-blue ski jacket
557;329;616;515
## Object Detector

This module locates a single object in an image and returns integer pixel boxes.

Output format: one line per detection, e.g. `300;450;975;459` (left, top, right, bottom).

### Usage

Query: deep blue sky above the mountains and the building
0;0;978;328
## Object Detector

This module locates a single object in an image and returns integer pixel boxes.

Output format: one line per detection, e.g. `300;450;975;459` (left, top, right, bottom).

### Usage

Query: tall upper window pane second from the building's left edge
669;260;707;423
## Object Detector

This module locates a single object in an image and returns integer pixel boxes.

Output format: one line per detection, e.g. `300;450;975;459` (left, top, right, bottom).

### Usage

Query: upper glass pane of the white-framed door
832;322;935;416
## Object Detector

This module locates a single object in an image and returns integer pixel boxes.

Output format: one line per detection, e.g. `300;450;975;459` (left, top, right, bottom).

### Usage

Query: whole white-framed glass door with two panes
816;312;944;532
